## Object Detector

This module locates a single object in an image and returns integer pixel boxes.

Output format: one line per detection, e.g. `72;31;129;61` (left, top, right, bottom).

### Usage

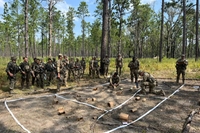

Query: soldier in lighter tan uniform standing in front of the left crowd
57;54;65;91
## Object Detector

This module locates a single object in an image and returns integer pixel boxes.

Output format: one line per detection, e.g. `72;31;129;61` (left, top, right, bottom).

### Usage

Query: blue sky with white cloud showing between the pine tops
0;0;180;36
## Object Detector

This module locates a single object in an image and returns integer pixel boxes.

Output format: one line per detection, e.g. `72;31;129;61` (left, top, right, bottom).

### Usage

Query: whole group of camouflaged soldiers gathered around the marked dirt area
6;54;188;95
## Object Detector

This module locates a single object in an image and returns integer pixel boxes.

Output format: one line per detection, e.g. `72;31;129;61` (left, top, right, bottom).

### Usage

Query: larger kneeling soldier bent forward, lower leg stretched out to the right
138;71;165;96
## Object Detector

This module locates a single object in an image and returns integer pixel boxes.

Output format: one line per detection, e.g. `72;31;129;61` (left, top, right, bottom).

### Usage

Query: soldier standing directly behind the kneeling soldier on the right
128;57;140;88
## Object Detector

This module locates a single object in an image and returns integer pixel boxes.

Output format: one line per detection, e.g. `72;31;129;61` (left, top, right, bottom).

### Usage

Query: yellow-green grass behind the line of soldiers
0;57;200;91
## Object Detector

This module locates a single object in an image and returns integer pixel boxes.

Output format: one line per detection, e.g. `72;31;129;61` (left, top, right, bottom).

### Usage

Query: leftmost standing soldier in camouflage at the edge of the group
6;57;19;94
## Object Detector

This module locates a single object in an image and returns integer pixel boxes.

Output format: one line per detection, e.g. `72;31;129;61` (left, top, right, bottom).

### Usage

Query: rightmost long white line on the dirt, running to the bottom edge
105;84;185;133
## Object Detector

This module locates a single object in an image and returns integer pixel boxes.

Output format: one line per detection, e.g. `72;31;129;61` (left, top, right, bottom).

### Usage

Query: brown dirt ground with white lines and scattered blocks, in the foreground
0;75;200;133
